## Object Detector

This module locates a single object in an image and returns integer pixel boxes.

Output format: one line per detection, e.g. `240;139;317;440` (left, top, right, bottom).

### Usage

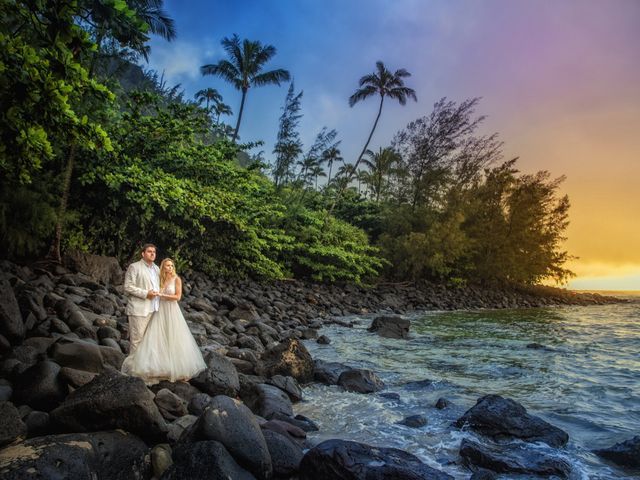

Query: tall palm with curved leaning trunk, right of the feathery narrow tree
349;61;418;183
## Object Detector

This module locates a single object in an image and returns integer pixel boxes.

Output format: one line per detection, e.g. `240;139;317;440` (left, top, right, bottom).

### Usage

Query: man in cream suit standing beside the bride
124;243;160;354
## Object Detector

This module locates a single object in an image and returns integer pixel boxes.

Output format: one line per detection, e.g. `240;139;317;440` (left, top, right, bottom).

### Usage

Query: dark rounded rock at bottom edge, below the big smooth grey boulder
161;440;255;480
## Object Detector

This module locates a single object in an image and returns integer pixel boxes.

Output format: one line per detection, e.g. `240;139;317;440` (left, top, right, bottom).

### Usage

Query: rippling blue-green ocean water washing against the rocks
296;297;640;480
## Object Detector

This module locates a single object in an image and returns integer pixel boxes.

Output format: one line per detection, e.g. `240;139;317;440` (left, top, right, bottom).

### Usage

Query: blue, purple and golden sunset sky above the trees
146;0;640;290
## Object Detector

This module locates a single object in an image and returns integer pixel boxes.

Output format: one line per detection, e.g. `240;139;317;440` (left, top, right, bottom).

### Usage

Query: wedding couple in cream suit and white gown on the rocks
122;243;207;385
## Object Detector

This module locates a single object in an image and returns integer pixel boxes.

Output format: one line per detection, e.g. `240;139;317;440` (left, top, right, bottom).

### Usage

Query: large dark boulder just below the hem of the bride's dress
51;372;167;441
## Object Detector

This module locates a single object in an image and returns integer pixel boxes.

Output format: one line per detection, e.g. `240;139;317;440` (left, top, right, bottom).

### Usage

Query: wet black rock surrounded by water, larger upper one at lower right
454;395;569;447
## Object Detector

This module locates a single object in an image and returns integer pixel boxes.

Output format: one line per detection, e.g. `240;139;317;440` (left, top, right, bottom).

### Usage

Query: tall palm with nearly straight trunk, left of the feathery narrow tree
200;34;290;142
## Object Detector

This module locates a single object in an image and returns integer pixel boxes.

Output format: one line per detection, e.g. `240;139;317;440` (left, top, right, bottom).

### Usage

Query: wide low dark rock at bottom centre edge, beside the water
298;440;453;480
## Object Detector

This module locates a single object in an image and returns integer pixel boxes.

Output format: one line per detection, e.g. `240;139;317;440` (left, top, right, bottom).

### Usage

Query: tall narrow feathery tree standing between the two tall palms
273;82;302;187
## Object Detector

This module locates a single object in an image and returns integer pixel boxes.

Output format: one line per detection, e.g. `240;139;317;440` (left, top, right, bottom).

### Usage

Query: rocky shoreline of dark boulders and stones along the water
0;255;640;479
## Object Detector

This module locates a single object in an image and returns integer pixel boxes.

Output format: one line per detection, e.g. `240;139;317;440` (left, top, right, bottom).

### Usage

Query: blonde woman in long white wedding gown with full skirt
122;258;207;385
